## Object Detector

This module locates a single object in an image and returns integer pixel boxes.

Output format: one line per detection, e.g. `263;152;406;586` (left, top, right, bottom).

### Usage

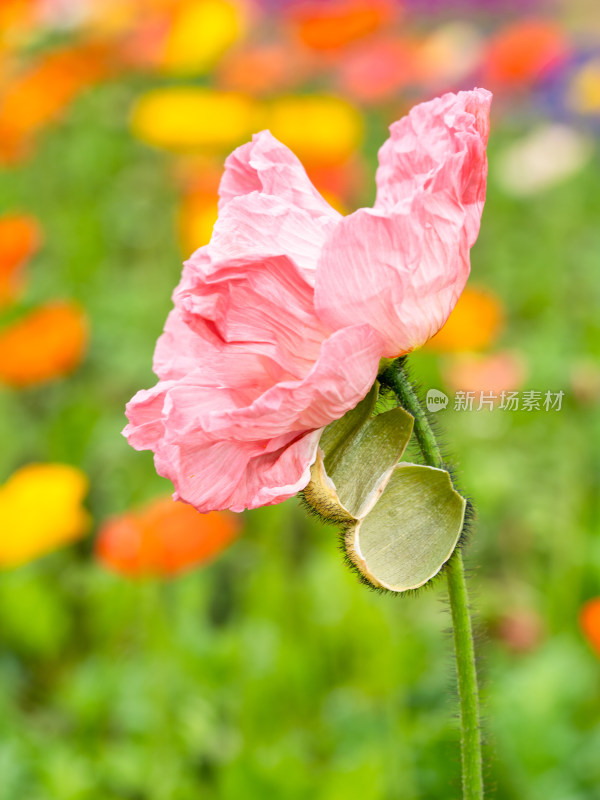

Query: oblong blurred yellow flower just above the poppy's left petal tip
131;86;264;151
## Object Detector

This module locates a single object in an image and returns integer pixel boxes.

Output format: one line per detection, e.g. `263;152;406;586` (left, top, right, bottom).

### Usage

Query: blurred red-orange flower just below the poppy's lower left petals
96;498;240;576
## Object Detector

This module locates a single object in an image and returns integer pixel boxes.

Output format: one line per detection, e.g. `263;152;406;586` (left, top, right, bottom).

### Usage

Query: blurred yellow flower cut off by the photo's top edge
161;0;245;74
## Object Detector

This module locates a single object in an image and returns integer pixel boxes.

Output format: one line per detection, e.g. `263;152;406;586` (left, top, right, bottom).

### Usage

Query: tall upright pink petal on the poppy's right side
315;89;490;358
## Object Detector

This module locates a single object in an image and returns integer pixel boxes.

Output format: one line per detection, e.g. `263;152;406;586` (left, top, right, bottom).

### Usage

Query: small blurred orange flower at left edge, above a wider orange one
0;214;41;308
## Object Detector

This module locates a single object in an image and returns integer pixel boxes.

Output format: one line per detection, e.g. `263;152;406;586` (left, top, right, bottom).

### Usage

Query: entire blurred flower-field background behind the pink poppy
0;0;600;800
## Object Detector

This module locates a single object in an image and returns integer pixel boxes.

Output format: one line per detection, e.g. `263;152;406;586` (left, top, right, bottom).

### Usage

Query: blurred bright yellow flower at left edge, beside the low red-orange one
0;464;90;568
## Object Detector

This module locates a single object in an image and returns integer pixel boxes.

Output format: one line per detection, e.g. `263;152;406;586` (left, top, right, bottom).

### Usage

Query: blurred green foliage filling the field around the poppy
0;76;600;800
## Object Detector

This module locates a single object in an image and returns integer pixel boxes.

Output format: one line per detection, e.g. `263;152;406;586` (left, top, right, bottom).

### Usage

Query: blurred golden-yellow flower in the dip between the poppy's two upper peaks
265;95;363;164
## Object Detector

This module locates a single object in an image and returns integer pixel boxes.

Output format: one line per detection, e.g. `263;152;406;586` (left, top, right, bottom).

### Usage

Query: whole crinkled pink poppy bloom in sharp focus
124;89;491;512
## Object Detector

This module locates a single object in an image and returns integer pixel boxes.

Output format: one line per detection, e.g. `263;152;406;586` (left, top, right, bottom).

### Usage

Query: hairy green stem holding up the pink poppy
381;361;483;800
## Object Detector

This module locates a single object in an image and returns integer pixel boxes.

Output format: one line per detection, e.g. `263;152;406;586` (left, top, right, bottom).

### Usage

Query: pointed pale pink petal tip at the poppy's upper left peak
219;131;340;220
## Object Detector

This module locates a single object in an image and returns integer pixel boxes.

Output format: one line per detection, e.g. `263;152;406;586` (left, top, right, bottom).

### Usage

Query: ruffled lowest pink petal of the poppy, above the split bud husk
125;326;381;511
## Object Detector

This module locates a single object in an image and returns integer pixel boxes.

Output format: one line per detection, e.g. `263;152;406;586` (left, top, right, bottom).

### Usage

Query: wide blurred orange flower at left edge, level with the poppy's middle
0;302;88;388
